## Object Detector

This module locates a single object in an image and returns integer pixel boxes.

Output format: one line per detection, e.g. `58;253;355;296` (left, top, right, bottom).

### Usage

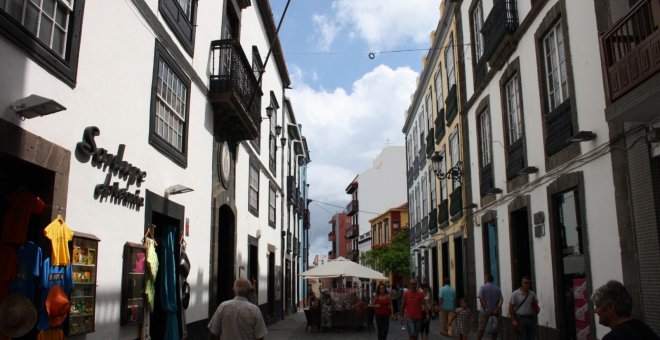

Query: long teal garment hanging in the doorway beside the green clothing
158;227;179;340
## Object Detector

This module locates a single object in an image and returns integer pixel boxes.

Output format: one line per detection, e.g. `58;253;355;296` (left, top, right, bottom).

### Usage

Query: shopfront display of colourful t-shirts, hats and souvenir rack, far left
0;185;98;339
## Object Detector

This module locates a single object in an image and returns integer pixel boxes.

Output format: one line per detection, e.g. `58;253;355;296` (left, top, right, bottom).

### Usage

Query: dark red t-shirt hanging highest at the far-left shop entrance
0;191;46;244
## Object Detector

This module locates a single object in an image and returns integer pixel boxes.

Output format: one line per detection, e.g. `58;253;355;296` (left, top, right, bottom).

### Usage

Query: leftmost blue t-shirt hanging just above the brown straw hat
11;241;41;301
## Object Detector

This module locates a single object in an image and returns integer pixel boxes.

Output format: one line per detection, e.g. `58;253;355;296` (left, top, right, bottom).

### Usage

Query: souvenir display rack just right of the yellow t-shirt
68;232;100;335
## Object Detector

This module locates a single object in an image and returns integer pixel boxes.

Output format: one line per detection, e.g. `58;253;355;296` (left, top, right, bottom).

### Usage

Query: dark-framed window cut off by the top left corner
0;0;85;87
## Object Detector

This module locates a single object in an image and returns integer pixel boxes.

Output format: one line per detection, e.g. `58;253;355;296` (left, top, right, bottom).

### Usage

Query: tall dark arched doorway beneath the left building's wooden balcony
216;205;236;305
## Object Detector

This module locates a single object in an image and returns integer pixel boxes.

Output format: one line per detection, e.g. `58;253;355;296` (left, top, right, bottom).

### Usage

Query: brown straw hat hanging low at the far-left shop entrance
0;293;37;338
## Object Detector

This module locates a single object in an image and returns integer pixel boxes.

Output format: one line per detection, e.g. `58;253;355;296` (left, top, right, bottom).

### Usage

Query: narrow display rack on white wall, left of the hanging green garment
121;242;147;325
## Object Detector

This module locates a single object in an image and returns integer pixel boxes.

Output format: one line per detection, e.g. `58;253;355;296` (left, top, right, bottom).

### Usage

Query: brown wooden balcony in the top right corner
600;0;660;104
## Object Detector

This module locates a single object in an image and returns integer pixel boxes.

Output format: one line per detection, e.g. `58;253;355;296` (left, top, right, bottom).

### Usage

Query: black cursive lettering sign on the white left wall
76;126;147;211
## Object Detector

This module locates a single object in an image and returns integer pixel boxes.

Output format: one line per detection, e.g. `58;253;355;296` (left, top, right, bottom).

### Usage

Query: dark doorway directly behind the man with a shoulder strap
511;208;534;287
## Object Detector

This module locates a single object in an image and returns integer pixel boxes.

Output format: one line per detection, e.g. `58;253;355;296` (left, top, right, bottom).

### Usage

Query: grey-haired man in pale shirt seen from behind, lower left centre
208;278;268;340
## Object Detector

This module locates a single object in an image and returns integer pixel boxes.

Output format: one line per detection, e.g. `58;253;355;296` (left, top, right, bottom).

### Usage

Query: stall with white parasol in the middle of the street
300;257;387;330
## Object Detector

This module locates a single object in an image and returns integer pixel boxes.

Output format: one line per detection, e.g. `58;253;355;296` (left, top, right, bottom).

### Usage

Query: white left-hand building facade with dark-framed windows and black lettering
0;0;309;339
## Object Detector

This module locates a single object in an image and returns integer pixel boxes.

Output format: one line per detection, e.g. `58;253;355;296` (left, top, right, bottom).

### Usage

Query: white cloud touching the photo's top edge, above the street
332;0;440;49
